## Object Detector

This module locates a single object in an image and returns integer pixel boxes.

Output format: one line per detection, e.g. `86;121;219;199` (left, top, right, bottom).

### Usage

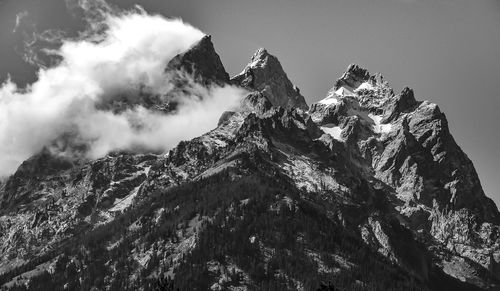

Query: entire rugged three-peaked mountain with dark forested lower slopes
0;37;500;290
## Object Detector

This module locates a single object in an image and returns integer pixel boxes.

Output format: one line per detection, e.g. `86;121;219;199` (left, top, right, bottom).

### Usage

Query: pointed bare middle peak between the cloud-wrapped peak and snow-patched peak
232;48;308;109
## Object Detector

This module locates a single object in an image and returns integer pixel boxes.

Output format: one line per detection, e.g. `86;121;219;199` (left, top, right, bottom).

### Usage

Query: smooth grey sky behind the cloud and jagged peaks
0;0;500;205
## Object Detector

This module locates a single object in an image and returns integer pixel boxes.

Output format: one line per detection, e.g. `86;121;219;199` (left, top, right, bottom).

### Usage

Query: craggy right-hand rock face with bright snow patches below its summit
310;65;500;287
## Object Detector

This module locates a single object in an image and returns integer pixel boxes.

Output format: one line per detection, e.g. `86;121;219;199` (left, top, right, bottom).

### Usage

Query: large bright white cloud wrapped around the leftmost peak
0;5;245;176
